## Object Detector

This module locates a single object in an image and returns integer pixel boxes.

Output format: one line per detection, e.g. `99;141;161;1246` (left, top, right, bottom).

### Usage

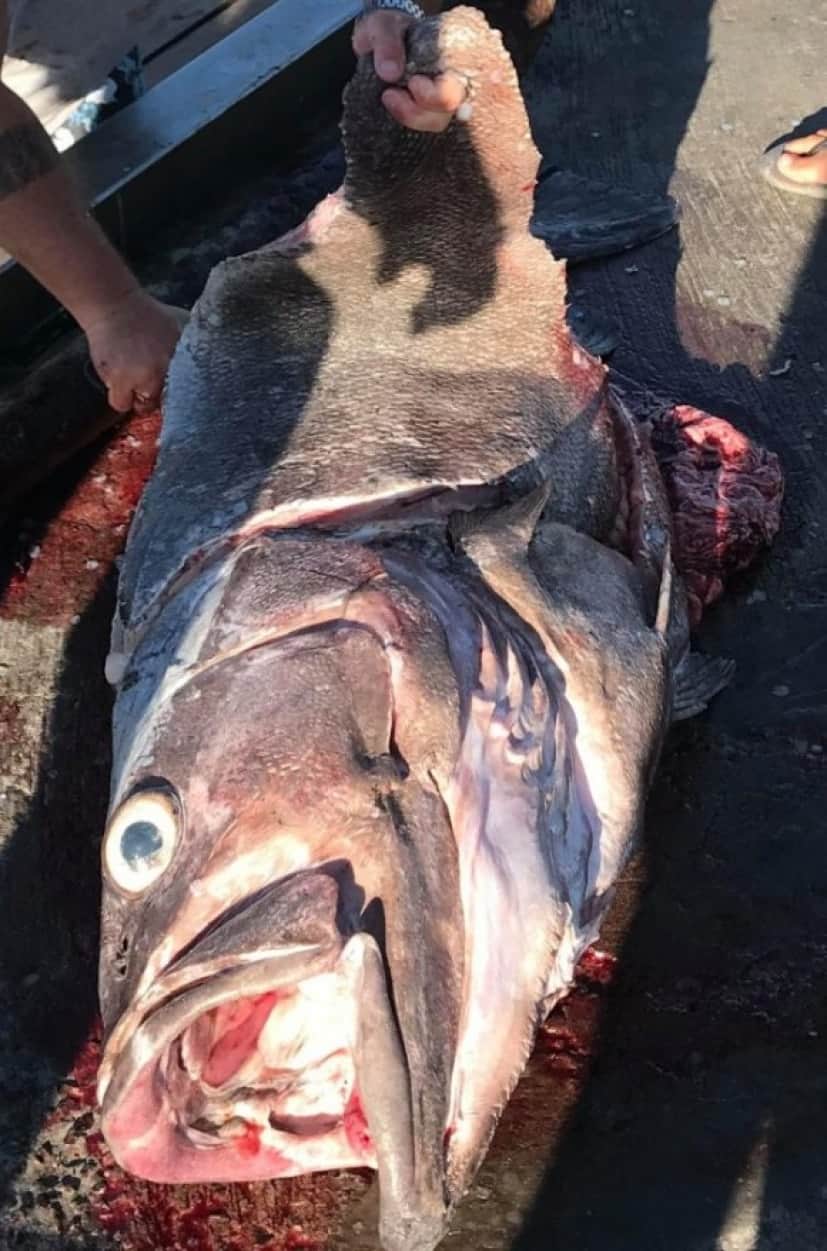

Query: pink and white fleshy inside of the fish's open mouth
104;973;377;1183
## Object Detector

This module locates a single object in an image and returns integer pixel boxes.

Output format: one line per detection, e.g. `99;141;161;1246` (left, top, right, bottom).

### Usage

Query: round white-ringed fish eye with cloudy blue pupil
104;791;180;896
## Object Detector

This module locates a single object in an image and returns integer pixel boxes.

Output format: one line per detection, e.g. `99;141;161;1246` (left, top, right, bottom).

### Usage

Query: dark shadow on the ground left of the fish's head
0;567;114;1230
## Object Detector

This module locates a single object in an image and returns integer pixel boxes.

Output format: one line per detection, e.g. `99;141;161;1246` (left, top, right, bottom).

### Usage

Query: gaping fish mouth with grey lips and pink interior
99;872;402;1183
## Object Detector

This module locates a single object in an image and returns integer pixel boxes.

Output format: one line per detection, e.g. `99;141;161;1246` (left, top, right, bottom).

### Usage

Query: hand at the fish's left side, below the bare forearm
83;289;186;413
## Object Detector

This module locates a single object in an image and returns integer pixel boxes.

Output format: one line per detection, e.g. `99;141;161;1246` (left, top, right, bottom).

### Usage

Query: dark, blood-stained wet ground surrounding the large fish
0;0;827;1251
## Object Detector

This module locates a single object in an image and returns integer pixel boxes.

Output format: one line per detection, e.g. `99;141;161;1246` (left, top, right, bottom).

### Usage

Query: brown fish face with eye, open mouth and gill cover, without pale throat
99;539;463;1251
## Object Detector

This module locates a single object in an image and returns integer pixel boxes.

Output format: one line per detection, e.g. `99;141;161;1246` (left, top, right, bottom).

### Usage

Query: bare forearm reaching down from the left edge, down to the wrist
0;83;138;329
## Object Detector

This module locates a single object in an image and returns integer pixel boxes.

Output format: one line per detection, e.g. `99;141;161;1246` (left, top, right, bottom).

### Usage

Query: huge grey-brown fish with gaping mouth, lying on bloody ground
99;9;728;1251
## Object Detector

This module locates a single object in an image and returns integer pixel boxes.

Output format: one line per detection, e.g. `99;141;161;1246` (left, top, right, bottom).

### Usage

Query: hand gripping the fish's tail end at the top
353;9;465;134
